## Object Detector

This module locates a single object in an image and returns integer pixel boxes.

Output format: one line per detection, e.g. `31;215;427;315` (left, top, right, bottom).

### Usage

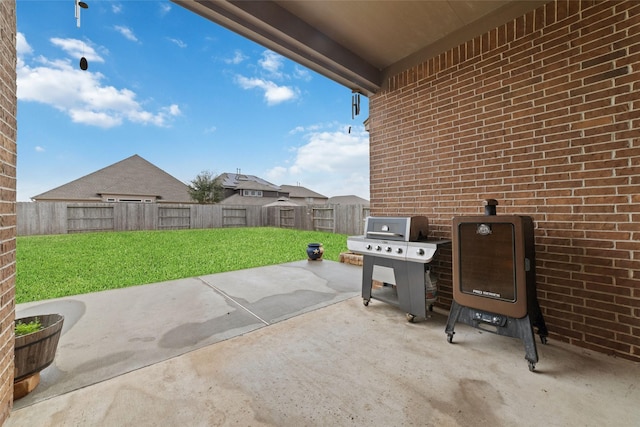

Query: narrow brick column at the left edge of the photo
0;0;17;425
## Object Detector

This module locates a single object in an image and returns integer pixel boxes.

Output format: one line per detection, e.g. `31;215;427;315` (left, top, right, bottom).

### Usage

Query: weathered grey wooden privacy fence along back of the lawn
17;202;369;236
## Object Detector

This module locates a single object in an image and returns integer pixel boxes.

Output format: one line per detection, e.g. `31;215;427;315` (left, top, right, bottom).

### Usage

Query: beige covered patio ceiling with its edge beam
173;0;547;95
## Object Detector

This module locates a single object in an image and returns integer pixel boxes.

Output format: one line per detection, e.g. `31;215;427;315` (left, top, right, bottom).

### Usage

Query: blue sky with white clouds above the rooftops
16;0;369;201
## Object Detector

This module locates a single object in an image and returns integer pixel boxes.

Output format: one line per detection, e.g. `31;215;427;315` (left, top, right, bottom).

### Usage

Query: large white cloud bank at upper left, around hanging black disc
16;34;180;128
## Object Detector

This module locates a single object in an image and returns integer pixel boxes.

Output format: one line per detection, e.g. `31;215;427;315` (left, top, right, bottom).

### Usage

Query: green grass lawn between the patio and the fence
16;227;347;304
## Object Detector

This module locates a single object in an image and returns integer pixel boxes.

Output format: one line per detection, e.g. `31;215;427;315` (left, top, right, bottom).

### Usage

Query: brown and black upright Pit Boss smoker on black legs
445;199;548;371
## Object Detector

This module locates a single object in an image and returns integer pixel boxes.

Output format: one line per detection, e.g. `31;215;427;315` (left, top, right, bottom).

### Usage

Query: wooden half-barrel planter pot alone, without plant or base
13;314;64;383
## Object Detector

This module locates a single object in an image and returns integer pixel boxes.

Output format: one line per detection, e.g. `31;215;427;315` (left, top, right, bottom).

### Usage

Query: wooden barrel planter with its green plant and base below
13;314;64;399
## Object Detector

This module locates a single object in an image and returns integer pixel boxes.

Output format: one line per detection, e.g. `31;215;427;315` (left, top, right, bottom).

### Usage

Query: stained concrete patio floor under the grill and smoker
5;260;640;426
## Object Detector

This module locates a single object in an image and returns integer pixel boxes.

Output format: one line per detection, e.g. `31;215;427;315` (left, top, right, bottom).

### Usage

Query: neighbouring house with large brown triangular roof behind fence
32;154;196;203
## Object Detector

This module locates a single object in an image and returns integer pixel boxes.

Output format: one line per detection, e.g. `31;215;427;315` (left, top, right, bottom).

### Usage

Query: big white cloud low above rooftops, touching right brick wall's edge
266;127;369;199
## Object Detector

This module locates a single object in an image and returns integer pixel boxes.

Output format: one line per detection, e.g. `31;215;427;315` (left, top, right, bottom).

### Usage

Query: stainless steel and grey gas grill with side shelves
347;216;449;322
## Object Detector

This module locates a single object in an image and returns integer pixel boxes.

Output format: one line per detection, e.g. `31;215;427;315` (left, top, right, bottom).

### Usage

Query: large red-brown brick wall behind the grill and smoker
370;0;640;361
